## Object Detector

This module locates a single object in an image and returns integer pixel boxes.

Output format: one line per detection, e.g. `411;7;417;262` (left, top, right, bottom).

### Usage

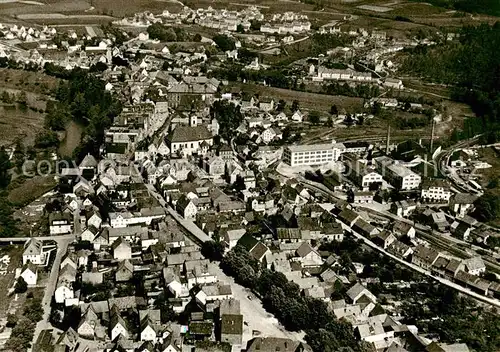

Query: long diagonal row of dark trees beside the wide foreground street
221;246;364;352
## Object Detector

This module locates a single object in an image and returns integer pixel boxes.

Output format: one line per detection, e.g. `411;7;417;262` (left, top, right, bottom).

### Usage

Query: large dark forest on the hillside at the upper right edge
402;23;500;143
